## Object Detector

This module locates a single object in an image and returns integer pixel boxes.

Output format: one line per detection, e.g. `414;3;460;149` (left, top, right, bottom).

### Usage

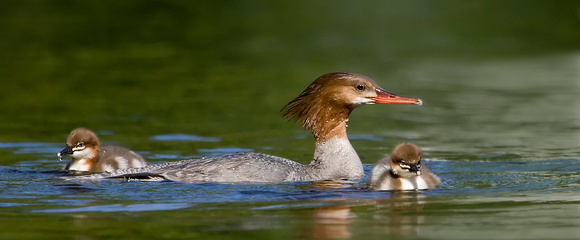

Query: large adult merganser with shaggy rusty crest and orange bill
77;72;422;183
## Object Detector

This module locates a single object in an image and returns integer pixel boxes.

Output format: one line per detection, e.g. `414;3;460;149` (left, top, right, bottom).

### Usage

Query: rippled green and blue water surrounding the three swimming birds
0;0;580;239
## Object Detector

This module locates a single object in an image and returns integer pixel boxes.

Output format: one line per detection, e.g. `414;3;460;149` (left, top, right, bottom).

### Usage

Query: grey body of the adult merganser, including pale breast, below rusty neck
73;138;364;183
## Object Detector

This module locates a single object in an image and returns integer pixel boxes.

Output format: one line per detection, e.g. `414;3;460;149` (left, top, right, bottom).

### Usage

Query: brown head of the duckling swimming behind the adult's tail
57;128;99;159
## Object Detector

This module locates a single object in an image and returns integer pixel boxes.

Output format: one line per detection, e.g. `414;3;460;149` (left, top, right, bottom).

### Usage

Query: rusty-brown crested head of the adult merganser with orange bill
282;72;423;142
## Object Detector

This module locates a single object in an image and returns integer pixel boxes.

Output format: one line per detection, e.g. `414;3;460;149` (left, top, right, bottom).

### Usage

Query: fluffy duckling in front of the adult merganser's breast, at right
369;143;441;190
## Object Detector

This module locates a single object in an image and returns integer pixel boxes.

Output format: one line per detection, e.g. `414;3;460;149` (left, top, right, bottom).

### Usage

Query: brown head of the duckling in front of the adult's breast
391;143;421;177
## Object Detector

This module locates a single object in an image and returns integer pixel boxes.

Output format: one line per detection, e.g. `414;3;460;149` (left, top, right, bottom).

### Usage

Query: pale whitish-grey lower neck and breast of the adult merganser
308;137;364;179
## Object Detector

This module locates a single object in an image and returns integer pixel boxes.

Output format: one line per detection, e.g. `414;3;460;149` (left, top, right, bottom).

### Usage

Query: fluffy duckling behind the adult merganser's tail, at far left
57;128;147;172
